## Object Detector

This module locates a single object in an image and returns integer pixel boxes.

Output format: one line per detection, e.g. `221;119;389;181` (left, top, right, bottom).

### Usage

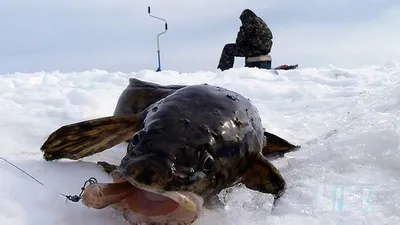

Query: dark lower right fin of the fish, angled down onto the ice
240;153;286;195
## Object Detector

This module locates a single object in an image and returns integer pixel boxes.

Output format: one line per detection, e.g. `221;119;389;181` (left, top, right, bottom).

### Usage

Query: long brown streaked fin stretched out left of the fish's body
40;113;143;161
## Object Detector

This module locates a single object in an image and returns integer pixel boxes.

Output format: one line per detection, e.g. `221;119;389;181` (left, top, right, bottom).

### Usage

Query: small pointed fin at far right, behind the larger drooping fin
262;131;300;158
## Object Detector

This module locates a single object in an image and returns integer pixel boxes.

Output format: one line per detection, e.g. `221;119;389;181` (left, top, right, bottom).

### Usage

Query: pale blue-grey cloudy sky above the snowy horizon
0;0;400;74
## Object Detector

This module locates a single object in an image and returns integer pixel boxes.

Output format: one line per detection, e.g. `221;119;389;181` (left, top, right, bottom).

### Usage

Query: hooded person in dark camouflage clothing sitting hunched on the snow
217;9;273;71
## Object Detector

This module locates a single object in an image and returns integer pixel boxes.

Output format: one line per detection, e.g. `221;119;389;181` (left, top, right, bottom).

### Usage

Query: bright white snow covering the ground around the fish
0;62;400;225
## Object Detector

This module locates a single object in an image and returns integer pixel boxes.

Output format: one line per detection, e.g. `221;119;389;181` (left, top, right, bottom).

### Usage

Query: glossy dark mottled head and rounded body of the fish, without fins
120;84;264;198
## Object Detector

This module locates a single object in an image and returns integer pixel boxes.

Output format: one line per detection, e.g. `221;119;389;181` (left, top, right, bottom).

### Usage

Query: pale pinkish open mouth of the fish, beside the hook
82;178;202;216
